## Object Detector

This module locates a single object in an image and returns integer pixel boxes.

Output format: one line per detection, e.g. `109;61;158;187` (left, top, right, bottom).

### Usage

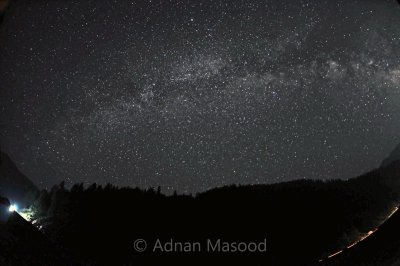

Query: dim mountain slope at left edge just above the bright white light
0;153;39;206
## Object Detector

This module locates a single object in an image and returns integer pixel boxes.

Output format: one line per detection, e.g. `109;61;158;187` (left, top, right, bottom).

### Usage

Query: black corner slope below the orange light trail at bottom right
320;208;400;266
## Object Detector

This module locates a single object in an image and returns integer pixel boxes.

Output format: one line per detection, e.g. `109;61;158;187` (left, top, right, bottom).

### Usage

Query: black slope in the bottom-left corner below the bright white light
0;207;74;266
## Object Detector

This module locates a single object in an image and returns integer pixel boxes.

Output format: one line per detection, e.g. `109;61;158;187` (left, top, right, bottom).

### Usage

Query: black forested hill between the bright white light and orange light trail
29;162;400;265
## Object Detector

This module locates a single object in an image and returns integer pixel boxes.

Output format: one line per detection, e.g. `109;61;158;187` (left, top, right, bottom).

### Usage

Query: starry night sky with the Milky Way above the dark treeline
0;0;400;193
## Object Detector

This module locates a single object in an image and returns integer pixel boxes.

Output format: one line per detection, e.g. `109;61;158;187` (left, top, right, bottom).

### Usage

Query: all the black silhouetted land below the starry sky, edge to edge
0;147;400;266
